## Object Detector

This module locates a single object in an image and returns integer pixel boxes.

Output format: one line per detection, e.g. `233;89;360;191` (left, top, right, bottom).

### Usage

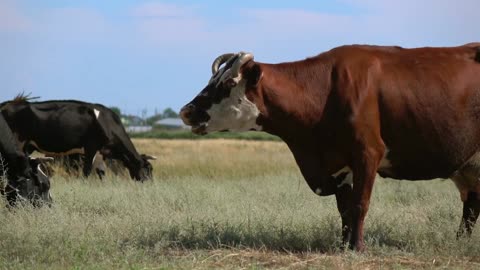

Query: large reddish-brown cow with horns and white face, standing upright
181;43;480;250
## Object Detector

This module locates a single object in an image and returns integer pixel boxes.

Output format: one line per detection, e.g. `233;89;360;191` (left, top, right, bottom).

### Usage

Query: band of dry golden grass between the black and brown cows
135;139;297;179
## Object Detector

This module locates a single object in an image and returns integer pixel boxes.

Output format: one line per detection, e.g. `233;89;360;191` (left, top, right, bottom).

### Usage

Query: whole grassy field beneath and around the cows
0;139;480;269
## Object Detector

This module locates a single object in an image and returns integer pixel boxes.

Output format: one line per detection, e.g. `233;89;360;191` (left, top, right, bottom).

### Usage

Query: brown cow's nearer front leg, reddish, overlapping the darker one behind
350;146;385;251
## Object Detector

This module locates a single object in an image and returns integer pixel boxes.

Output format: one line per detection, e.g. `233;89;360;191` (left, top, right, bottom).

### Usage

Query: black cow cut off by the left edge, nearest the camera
0;114;52;206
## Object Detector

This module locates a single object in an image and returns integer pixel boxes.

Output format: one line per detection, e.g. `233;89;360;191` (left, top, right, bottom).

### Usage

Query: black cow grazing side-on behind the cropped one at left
0;97;156;181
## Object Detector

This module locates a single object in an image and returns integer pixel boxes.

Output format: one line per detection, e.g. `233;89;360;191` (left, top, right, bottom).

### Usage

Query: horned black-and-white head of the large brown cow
180;52;262;135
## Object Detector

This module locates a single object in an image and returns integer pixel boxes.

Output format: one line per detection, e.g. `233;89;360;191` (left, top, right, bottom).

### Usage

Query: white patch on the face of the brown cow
206;70;262;132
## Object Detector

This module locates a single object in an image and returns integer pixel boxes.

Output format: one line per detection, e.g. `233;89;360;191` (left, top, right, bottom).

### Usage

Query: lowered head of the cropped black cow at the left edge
2;158;52;206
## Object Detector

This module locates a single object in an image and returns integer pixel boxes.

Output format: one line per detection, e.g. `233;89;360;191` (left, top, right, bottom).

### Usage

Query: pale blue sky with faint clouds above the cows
0;0;480;115
